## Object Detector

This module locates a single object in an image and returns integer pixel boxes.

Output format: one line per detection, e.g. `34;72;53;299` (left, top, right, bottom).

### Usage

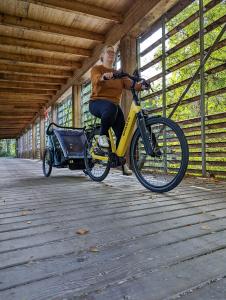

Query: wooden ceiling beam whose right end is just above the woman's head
0;14;104;42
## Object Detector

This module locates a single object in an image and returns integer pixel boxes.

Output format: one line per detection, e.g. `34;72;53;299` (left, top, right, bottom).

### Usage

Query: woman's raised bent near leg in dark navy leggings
89;100;118;135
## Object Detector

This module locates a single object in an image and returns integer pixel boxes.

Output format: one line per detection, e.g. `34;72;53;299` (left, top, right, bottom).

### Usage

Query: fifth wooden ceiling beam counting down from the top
0;64;73;78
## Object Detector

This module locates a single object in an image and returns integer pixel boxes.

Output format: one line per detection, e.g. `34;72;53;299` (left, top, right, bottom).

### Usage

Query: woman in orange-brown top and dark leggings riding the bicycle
89;45;146;175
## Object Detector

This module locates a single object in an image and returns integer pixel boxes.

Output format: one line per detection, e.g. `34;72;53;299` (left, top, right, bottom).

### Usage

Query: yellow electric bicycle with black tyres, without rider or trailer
84;72;189;192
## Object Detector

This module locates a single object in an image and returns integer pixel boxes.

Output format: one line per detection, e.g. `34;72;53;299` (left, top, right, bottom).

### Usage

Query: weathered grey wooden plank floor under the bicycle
0;158;226;300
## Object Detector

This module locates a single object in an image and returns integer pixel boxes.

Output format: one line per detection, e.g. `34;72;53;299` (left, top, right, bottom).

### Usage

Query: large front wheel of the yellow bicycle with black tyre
130;117;189;193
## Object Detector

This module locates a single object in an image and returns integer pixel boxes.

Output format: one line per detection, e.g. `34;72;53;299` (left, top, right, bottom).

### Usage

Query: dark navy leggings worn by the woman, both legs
89;99;125;146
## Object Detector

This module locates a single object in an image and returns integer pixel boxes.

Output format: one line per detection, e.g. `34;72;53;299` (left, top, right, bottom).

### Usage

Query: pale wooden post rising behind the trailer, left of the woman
72;85;81;127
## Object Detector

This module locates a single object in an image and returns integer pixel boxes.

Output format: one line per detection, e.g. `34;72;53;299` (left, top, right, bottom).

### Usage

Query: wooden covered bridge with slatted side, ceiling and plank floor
0;0;226;300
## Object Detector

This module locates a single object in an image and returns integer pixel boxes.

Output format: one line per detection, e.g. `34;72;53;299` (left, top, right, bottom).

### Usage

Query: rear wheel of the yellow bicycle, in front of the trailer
84;136;110;181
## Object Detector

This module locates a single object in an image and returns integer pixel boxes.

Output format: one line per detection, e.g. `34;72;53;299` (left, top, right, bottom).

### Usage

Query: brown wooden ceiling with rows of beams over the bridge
0;0;178;138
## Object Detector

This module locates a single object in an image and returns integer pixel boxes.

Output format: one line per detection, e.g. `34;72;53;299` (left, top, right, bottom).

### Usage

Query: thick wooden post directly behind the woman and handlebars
119;35;137;164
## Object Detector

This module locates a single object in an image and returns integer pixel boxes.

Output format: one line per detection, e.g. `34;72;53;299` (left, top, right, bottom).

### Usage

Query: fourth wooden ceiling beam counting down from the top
0;52;82;70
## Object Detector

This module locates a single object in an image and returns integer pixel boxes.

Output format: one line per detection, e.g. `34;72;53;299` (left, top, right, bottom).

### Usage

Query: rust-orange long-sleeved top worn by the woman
90;65;141;104
